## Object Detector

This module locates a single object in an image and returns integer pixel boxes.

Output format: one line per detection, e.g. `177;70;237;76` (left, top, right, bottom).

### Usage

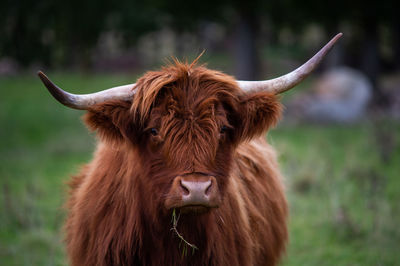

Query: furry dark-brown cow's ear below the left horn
83;101;135;142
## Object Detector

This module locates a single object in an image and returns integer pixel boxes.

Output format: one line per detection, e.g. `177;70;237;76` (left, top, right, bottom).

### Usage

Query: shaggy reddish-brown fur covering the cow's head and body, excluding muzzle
65;62;287;266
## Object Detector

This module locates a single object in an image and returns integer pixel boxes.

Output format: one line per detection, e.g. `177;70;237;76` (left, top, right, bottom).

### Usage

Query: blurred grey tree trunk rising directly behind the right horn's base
234;10;259;80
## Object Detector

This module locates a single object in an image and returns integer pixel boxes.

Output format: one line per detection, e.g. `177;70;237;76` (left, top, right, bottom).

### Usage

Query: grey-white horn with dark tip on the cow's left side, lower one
37;71;135;110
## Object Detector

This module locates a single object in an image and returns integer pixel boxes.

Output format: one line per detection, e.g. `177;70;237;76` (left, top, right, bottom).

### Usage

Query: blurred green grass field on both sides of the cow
0;73;400;266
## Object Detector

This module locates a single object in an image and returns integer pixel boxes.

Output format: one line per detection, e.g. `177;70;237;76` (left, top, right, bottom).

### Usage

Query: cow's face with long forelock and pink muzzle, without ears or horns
140;72;238;212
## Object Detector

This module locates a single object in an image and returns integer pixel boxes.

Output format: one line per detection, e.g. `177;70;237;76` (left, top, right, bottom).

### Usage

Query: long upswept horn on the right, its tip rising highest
237;33;343;94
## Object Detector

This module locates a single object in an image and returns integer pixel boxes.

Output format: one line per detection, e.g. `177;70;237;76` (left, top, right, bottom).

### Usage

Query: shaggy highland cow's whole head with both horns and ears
39;34;341;215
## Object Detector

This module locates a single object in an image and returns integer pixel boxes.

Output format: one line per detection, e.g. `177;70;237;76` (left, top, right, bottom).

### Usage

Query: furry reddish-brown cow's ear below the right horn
237;92;282;141
